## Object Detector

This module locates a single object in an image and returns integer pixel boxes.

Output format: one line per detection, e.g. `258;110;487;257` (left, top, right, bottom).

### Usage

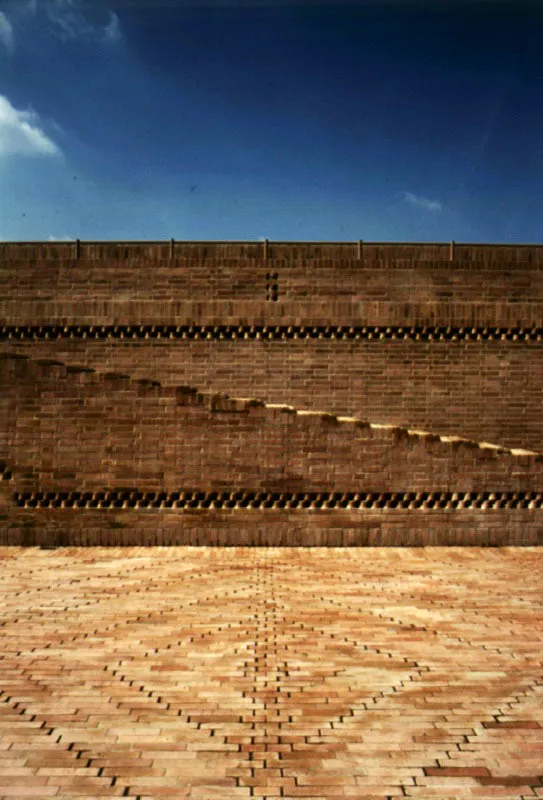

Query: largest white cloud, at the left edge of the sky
0;95;61;158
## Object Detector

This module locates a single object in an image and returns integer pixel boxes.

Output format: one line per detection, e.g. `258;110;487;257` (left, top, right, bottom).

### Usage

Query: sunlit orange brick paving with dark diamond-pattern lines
0;547;543;800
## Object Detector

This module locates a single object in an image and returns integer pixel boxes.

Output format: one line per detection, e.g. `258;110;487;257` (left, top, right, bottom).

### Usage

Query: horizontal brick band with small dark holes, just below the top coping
0;259;543;306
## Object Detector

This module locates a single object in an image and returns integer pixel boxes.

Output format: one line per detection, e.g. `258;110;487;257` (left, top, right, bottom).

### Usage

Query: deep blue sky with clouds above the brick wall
0;0;543;243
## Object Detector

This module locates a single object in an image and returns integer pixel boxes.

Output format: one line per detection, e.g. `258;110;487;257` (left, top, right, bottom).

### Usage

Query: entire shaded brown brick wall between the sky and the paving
0;241;543;546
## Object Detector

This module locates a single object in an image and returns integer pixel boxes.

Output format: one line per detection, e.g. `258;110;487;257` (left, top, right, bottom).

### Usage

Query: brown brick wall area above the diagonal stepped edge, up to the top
0;247;543;449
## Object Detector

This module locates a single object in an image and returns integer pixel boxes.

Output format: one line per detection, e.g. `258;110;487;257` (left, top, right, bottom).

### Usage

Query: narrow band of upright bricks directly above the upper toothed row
0;298;542;331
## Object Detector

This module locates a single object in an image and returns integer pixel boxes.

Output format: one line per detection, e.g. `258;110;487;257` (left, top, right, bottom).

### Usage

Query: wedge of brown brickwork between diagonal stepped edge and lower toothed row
0;358;543;492
